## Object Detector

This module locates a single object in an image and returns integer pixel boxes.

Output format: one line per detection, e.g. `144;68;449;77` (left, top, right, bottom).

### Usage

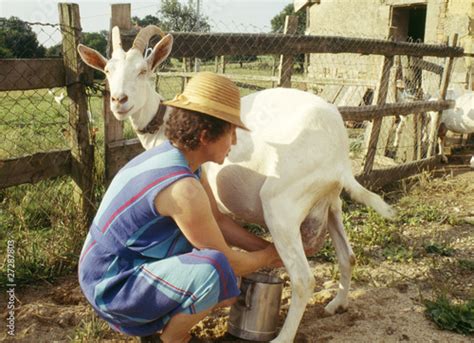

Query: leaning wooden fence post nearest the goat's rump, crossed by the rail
363;56;393;174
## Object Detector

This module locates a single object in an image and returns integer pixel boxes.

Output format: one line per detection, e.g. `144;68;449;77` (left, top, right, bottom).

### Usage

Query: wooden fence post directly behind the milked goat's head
103;4;132;183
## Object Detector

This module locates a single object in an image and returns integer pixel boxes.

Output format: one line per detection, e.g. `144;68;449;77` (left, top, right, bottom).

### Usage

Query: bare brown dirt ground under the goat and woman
0;170;474;343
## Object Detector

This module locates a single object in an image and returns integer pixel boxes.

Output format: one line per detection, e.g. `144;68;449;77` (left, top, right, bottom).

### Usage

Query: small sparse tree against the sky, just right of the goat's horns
160;0;211;32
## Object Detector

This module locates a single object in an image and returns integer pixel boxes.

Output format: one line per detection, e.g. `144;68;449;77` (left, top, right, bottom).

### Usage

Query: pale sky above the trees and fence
0;0;293;46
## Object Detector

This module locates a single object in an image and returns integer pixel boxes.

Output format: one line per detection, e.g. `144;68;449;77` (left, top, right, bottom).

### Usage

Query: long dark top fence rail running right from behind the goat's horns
121;29;464;58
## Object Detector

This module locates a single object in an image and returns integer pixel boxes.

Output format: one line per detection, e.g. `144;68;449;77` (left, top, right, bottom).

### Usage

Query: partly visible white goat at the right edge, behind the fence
428;90;474;163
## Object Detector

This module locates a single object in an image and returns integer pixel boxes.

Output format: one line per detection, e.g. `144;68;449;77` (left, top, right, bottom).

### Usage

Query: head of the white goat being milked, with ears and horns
77;25;173;120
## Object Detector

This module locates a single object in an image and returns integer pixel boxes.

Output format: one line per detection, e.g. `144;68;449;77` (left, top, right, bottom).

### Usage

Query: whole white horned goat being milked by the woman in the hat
78;27;394;342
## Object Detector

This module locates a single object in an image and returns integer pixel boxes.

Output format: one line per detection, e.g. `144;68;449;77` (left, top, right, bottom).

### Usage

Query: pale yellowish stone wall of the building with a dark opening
308;0;474;94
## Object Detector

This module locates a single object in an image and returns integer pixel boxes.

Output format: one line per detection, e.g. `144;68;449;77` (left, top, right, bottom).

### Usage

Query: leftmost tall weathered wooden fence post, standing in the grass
58;3;94;226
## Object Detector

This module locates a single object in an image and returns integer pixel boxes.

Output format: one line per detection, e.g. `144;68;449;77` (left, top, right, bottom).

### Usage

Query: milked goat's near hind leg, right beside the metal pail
262;188;315;343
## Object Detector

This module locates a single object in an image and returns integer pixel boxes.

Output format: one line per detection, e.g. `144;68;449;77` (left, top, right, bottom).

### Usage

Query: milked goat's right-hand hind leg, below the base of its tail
325;198;355;314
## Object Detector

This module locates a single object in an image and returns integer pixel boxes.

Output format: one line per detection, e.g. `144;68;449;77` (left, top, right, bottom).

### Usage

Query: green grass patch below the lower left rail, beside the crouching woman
0;177;84;286
